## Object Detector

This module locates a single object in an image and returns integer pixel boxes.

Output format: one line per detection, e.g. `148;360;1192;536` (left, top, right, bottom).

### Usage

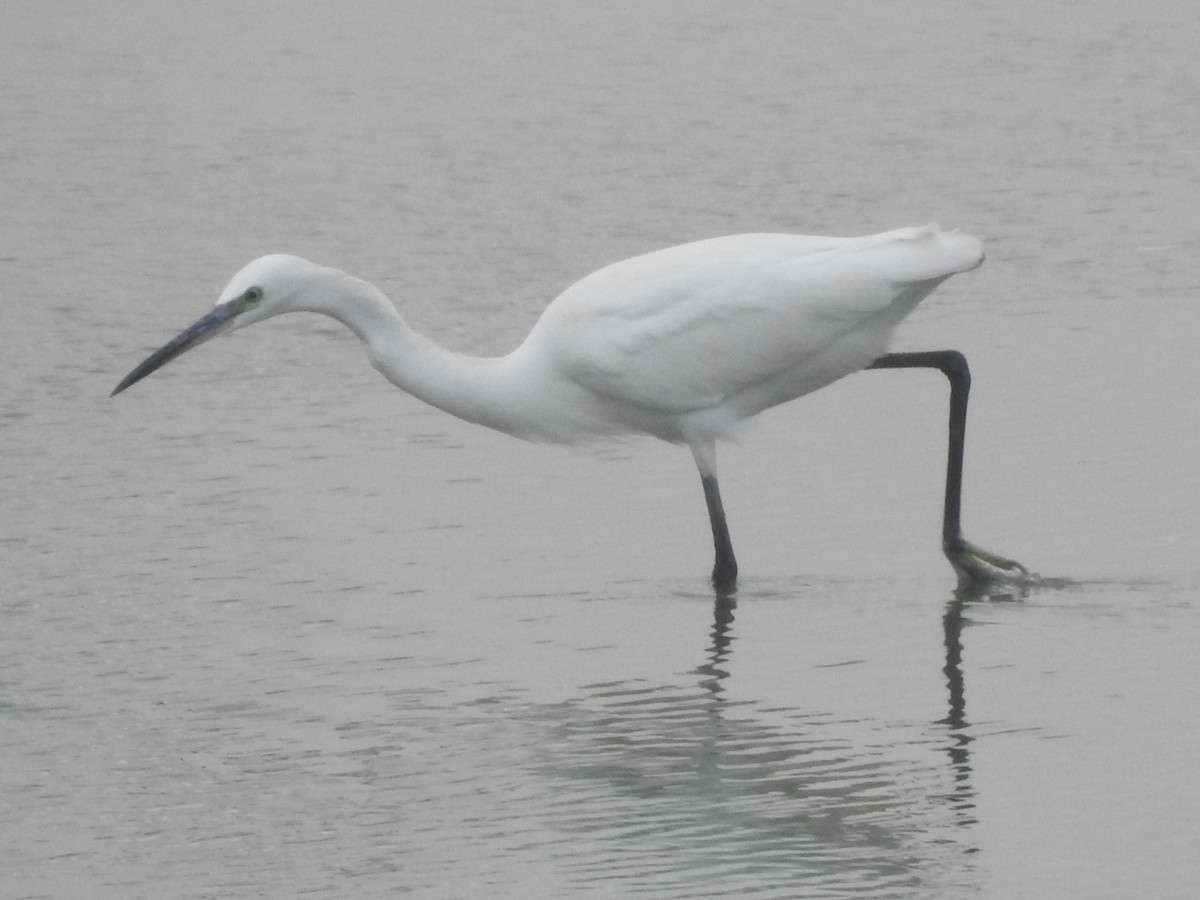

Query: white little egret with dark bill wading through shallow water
113;226;1026;592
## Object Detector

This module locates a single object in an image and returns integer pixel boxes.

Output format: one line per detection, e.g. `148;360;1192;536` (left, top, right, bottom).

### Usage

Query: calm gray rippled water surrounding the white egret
0;0;1200;899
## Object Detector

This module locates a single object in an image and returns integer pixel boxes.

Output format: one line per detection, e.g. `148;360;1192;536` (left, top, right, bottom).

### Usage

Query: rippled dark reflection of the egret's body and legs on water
536;594;993;896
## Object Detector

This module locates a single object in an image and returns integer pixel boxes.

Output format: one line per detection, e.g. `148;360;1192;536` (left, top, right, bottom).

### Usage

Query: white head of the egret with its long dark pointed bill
113;253;320;396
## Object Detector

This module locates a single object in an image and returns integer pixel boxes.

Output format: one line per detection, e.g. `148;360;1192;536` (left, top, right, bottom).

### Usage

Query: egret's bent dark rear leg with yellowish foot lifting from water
868;350;1030;587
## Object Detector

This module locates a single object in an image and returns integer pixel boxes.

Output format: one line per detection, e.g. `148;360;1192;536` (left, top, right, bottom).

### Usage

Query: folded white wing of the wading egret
528;226;983;414
